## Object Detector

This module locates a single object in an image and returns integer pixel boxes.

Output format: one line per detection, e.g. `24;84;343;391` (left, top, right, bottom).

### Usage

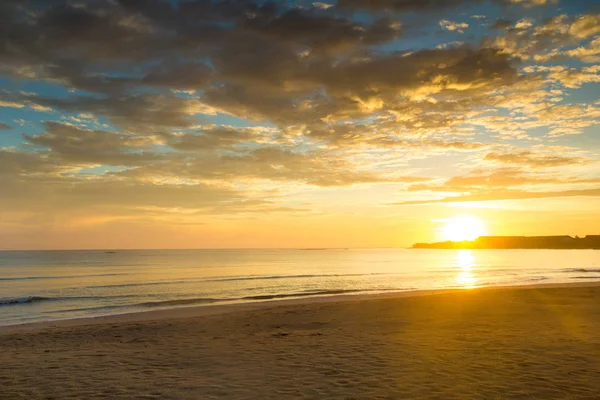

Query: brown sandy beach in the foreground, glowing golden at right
0;284;600;399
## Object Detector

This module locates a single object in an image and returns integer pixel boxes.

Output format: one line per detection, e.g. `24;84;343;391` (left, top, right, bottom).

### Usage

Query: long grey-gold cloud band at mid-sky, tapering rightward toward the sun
10;122;432;187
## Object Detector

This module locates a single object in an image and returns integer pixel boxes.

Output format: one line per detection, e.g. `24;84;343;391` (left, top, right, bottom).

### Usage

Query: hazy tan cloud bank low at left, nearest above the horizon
0;150;304;219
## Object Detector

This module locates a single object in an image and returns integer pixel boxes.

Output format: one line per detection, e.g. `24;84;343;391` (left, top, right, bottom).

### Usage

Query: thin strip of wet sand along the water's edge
0;281;600;335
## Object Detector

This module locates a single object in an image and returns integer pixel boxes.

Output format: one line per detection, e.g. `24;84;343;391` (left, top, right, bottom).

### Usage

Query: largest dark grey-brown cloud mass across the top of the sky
3;1;536;141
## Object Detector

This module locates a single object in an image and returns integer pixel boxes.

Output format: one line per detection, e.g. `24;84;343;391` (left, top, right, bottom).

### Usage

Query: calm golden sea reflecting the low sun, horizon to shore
0;249;600;325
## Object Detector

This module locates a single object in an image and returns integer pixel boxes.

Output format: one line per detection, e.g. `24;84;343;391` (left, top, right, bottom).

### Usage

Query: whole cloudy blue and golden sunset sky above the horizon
0;0;600;249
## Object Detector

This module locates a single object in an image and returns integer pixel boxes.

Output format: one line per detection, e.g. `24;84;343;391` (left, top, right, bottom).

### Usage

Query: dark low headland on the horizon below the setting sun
413;235;600;250
